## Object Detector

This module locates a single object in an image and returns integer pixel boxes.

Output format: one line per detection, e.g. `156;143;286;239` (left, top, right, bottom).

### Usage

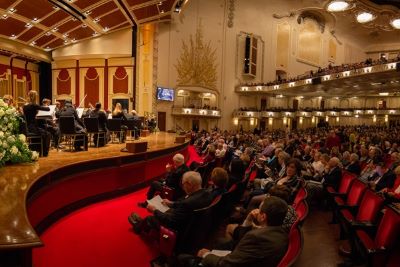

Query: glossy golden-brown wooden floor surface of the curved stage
0;132;188;248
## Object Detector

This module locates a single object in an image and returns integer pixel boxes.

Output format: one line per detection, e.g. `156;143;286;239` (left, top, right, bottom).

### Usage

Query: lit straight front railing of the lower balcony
233;109;400;118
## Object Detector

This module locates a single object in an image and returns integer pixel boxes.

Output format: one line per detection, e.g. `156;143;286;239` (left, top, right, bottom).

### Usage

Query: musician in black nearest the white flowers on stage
23;90;51;157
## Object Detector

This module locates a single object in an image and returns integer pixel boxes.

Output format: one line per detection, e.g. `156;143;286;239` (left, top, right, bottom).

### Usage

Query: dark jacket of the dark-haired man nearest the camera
201;226;288;267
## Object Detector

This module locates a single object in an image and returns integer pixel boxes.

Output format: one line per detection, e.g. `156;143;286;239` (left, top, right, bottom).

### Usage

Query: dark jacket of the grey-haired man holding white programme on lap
154;189;212;231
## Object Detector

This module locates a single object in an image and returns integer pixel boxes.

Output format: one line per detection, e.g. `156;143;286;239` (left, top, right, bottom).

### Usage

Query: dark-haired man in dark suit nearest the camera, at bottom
198;196;288;267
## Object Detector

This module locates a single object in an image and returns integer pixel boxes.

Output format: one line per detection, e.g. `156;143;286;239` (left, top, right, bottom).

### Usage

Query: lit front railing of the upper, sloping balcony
235;62;400;94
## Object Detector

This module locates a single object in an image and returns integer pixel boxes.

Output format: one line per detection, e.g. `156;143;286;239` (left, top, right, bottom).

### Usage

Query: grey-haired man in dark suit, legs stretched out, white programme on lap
128;171;212;234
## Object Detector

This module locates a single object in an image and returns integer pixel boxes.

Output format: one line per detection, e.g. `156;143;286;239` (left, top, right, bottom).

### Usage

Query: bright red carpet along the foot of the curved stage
33;146;201;267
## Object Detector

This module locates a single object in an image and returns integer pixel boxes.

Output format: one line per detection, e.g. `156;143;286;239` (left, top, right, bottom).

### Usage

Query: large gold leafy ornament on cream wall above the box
175;23;217;90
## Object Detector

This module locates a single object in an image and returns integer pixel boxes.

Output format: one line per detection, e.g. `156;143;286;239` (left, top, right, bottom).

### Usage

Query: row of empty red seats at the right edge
327;172;400;266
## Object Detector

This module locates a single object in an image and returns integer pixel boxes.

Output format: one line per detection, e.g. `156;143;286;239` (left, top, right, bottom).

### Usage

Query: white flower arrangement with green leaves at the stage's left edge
0;99;39;167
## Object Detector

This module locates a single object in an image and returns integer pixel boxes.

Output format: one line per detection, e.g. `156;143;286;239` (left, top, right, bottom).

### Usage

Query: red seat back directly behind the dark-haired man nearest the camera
277;223;303;267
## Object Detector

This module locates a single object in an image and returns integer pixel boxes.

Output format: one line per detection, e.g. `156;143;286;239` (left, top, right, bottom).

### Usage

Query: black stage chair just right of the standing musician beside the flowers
59;116;86;151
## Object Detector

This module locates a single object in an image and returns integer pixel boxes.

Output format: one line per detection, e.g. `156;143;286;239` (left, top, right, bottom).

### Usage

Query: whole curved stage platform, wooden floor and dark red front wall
0;132;188;255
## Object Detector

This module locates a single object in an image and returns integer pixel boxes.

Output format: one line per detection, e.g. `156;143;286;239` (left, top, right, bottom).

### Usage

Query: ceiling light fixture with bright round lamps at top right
325;0;400;31
